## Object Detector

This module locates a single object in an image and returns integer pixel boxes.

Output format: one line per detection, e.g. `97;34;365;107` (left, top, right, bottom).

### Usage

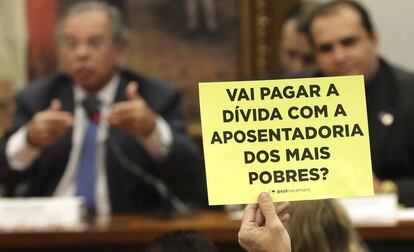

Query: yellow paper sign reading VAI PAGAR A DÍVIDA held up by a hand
199;76;373;205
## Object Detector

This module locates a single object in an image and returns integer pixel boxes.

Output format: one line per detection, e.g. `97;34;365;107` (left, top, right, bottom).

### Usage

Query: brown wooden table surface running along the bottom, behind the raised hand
0;211;414;247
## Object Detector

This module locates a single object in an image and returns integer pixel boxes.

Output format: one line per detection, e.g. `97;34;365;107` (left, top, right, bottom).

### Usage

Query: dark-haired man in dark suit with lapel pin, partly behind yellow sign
301;0;414;206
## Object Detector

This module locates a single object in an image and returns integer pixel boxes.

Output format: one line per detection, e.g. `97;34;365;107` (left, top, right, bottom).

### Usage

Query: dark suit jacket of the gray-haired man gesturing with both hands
0;70;205;212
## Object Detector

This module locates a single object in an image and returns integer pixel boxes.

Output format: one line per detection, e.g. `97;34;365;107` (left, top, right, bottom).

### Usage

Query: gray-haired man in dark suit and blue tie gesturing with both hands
0;2;204;213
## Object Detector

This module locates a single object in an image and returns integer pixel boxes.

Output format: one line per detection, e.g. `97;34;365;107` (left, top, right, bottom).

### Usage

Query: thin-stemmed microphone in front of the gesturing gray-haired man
82;97;190;214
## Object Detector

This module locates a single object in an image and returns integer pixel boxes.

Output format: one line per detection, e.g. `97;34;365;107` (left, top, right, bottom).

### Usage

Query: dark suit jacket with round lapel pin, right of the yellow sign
295;59;414;206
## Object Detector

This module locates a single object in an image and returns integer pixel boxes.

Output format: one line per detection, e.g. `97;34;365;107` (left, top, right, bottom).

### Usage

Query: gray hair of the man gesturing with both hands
55;1;130;45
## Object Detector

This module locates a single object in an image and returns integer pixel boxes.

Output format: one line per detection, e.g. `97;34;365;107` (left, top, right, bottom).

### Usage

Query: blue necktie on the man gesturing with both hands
76;97;99;213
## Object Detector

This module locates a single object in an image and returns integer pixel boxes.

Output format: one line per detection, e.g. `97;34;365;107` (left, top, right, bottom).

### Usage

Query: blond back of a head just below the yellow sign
286;199;367;252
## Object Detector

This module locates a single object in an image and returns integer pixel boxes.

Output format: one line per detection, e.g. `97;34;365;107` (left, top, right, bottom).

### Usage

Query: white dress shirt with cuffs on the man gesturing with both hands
6;75;172;214
